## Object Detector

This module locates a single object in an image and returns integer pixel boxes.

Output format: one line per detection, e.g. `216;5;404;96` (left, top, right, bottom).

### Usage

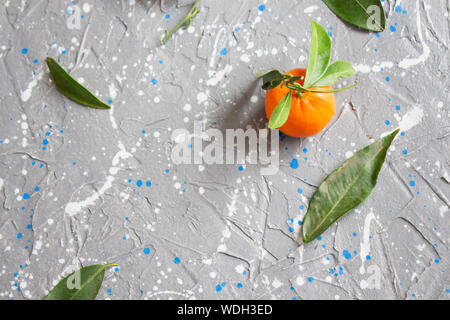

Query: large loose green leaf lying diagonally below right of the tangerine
303;129;400;243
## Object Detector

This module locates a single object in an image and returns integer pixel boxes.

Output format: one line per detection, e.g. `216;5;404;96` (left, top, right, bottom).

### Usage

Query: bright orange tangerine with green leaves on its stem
266;69;336;138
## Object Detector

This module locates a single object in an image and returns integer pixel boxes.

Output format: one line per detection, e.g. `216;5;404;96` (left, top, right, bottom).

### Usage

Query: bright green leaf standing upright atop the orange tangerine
303;21;331;89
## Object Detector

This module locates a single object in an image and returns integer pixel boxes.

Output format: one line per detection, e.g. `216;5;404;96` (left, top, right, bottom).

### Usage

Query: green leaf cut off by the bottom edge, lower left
45;263;116;300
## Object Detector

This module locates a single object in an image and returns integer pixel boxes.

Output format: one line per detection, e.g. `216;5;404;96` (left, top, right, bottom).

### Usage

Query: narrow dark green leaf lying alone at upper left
46;57;111;109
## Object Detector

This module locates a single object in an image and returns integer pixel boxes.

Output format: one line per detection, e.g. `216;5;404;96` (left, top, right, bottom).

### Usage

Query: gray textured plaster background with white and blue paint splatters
0;0;450;299
